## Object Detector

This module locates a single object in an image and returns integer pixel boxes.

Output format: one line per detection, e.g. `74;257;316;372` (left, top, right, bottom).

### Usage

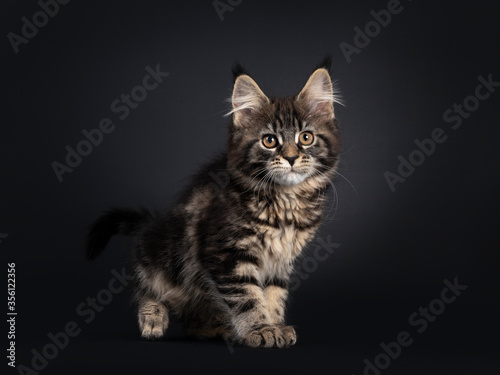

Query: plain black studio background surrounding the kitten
0;0;500;374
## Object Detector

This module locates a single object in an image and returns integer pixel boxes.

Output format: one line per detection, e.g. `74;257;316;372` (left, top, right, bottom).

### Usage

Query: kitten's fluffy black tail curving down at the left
85;208;152;260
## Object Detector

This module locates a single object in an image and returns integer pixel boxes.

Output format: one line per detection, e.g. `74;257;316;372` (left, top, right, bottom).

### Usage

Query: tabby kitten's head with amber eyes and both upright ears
228;60;340;192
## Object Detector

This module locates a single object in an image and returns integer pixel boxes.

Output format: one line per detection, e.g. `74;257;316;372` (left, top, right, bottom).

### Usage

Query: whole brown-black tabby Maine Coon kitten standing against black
87;62;340;348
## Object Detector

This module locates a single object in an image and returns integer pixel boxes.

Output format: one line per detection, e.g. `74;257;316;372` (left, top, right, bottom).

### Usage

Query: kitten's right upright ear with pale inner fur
296;68;335;118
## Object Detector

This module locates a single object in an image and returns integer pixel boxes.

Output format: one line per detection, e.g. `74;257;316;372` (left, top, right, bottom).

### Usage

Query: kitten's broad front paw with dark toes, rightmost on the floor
242;325;297;348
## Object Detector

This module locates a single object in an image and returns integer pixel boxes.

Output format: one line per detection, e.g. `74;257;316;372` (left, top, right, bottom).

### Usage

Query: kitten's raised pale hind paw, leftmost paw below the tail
138;297;168;340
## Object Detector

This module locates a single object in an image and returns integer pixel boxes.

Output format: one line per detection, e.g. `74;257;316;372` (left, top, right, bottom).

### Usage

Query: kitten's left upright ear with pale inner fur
229;74;269;126
